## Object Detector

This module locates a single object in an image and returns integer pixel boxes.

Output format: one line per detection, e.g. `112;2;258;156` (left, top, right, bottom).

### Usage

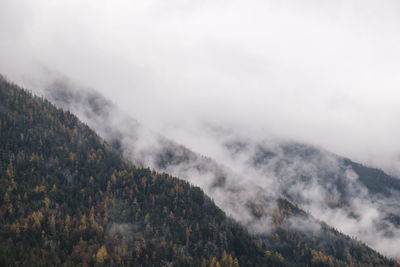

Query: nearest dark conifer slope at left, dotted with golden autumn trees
0;78;286;266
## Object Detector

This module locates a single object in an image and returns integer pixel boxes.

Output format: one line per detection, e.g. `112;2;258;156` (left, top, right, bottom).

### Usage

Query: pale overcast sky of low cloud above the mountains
0;0;400;175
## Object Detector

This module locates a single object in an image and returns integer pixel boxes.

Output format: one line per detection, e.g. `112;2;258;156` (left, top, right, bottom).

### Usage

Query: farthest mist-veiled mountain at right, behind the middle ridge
225;139;400;257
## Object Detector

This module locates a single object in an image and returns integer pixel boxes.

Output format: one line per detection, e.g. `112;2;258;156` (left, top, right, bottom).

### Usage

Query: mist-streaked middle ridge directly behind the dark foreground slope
38;77;400;265
